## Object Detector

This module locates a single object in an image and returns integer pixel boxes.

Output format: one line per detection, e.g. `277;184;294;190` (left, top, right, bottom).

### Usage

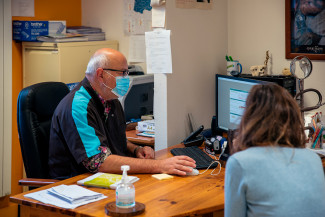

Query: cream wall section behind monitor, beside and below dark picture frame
228;0;325;112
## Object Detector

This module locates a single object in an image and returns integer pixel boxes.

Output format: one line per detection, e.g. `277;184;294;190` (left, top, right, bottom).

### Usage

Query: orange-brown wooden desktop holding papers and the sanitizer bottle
10;145;224;217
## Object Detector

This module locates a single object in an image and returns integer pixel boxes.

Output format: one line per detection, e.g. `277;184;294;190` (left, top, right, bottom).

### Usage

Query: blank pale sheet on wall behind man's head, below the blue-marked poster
128;35;146;63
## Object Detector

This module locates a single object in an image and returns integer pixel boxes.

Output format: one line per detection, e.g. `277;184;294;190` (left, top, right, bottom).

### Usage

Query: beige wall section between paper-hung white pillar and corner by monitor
167;0;228;146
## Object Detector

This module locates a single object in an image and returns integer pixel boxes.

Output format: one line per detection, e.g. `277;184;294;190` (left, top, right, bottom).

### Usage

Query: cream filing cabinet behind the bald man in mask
23;41;118;87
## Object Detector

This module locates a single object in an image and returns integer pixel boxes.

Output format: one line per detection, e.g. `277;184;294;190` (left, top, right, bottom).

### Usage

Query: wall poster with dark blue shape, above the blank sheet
124;0;152;35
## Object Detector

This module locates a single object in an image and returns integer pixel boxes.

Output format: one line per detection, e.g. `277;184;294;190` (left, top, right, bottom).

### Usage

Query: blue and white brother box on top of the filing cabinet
12;20;66;41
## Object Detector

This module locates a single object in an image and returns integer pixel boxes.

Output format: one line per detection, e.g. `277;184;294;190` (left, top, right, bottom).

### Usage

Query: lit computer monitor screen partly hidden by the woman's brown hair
216;75;266;130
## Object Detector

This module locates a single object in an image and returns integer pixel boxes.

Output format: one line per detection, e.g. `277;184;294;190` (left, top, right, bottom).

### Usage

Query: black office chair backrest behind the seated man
17;82;69;179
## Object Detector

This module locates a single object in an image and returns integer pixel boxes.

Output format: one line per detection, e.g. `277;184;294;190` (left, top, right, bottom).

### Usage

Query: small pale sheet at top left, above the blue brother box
11;0;35;17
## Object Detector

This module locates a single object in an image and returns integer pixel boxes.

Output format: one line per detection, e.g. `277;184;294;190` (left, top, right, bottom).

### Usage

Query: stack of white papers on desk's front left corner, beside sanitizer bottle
25;185;107;209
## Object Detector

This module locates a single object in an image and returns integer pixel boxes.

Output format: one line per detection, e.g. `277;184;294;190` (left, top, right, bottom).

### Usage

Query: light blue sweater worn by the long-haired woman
225;147;325;217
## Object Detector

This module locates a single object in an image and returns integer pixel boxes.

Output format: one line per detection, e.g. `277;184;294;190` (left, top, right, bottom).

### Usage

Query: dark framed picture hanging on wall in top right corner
285;0;325;60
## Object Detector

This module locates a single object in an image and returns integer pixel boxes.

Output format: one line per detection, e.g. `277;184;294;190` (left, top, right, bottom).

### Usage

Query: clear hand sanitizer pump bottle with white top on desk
116;165;135;208
